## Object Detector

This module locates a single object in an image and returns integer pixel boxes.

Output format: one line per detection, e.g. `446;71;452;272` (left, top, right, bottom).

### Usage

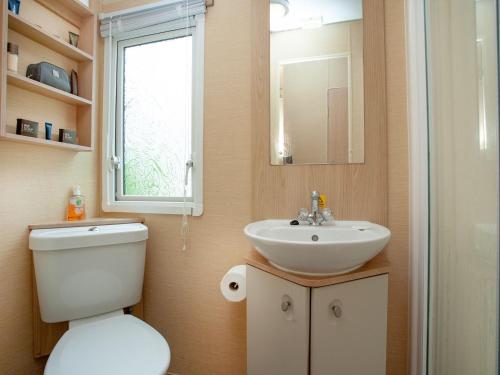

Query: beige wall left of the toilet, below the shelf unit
0;142;98;375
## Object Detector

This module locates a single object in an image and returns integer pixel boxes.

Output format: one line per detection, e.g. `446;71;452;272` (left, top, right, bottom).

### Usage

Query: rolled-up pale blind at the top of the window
99;0;206;38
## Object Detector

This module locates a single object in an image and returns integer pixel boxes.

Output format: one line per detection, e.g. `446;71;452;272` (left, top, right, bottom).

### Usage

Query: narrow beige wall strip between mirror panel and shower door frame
385;0;410;375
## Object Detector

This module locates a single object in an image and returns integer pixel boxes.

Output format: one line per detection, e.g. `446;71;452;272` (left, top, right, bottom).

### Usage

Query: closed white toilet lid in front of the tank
44;315;170;375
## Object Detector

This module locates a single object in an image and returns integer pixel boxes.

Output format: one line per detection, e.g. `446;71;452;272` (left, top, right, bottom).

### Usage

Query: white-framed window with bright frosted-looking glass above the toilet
101;4;204;216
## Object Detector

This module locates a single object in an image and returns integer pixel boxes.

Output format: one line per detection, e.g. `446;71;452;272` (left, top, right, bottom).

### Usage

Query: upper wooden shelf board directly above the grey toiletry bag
8;12;94;61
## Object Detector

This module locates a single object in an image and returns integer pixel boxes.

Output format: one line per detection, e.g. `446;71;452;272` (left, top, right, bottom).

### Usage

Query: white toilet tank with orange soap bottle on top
29;223;148;323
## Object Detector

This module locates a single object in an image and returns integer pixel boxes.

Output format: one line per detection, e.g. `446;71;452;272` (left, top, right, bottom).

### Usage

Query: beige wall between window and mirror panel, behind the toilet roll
99;0;252;375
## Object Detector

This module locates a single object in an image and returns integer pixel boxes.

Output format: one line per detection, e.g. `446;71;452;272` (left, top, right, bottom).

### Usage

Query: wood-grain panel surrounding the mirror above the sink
252;0;387;225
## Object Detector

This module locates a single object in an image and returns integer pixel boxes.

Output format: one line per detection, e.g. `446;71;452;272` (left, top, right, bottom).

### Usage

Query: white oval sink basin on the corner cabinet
245;220;391;276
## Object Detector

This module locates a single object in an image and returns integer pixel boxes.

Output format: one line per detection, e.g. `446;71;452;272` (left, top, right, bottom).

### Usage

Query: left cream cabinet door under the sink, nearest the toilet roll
247;266;310;375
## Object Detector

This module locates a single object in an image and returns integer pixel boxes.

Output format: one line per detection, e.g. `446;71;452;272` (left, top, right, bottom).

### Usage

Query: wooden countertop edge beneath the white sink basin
246;250;389;288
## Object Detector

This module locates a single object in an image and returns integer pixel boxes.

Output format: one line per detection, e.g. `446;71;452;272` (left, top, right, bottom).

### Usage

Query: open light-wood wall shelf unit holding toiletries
0;0;97;152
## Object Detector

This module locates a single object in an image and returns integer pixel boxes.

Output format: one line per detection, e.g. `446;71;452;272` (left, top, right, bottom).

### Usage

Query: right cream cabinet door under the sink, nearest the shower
311;275;388;375
